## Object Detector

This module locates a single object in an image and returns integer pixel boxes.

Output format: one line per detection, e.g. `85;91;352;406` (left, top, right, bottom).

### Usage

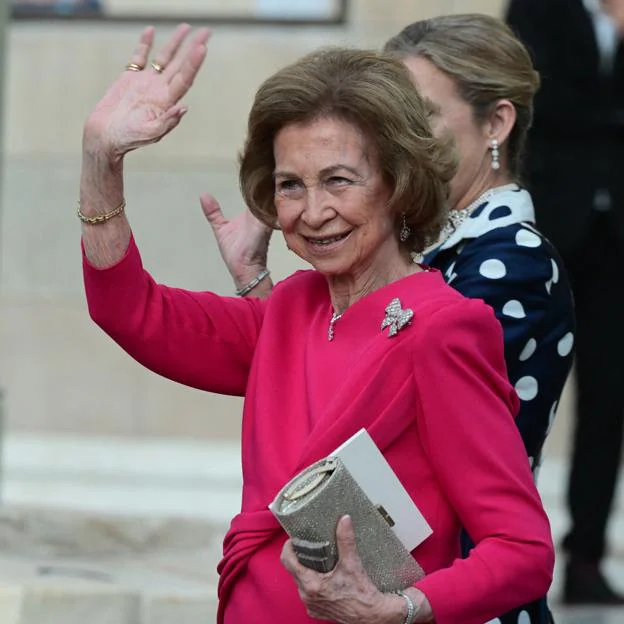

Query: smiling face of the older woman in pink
274;117;399;276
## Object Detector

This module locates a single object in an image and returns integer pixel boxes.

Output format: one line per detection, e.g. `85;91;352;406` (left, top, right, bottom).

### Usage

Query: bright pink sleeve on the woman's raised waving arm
83;239;264;396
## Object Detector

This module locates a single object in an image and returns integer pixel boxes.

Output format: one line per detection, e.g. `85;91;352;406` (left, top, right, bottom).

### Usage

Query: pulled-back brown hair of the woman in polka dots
384;13;540;177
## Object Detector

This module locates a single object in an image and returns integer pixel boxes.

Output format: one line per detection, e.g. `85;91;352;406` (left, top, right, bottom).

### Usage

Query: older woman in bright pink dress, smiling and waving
79;26;553;624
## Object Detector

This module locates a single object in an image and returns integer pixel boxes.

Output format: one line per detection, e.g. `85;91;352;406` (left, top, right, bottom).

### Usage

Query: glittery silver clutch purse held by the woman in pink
271;457;424;592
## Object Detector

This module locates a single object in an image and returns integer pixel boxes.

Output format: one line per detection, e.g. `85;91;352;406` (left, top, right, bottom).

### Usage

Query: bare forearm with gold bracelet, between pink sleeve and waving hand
80;144;132;268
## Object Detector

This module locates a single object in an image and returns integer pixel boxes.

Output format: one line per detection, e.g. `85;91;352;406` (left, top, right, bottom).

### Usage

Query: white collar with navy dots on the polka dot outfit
434;186;535;253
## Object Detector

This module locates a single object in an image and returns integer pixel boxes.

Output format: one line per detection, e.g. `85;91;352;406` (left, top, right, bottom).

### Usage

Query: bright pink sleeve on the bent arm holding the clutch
414;301;554;624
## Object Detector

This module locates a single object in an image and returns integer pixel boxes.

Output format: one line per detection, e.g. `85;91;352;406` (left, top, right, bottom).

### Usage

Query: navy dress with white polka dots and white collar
423;186;574;624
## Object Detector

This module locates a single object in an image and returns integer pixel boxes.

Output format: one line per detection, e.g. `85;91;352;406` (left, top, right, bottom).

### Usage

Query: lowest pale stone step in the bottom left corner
0;558;216;624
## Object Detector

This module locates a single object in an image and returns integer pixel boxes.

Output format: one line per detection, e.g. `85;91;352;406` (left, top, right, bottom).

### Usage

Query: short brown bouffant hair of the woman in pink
240;48;455;251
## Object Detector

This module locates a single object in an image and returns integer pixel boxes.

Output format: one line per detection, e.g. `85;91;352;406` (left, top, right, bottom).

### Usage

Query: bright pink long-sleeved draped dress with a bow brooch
84;240;554;624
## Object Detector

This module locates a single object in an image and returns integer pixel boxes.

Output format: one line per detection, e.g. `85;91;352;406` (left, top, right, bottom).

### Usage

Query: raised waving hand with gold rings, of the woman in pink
83;24;210;160
